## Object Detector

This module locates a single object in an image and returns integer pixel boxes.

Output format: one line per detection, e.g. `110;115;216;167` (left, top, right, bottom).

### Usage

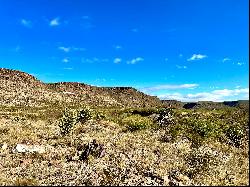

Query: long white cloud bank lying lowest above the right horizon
158;88;249;102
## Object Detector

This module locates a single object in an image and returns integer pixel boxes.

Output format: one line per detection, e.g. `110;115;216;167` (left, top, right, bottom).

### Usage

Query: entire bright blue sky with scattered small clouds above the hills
0;0;249;101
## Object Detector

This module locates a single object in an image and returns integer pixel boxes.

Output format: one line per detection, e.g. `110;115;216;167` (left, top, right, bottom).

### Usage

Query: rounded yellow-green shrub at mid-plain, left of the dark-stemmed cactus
122;114;153;131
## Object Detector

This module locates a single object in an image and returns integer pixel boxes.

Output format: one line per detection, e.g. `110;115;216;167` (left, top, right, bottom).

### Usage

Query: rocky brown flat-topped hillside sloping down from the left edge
0;68;162;107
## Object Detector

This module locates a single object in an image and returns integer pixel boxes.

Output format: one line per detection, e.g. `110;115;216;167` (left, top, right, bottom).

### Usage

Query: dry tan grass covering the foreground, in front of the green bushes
0;112;249;185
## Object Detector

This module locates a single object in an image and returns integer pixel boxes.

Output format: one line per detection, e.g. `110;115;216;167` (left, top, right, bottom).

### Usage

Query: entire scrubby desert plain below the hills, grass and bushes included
0;105;249;185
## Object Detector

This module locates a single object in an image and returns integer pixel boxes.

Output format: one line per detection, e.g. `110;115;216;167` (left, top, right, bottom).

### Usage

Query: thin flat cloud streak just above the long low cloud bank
141;84;199;92
